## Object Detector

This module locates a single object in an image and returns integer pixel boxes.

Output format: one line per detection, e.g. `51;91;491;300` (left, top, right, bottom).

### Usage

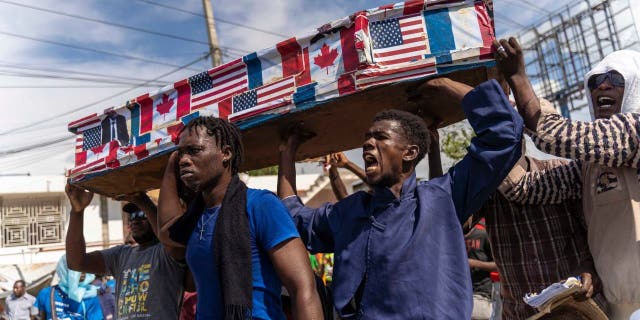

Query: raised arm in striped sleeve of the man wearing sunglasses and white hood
494;38;640;168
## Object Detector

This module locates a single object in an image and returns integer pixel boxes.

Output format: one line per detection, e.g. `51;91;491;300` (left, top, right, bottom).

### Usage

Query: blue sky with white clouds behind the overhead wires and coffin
0;0;637;175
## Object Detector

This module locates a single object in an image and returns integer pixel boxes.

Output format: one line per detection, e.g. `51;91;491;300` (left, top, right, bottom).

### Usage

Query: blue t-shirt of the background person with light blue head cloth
34;286;103;320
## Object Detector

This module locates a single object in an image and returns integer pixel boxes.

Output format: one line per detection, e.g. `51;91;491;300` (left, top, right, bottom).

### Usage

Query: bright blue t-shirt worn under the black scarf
186;189;299;319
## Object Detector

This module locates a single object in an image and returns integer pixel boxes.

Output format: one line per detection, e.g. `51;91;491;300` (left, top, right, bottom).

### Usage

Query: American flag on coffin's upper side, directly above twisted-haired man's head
189;59;248;110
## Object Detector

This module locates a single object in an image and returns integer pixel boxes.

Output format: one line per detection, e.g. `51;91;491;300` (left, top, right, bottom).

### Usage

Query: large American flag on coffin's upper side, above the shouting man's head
369;14;428;67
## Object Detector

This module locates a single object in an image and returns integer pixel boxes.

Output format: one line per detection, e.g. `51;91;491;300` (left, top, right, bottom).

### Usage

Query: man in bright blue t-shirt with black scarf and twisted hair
158;117;322;319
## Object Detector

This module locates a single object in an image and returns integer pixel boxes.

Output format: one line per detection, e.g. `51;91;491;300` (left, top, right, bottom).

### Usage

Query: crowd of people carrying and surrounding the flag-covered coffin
1;38;640;320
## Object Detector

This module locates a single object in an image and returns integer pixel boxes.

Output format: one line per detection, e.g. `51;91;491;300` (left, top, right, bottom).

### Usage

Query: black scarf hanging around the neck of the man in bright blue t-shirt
169;174;253;320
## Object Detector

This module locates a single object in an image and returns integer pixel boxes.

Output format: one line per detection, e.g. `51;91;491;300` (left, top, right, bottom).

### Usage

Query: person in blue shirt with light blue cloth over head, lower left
34;256;103;320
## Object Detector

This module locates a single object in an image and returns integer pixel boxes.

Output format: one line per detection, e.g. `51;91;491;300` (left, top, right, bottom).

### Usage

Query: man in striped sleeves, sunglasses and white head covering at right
496;38;640;320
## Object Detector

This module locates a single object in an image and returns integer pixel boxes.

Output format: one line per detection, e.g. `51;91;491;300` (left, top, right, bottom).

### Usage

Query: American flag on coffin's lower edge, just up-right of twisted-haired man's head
229;77;295;121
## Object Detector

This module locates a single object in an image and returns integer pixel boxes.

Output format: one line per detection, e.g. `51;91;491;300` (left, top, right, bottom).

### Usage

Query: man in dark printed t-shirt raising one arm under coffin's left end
66;188;186;320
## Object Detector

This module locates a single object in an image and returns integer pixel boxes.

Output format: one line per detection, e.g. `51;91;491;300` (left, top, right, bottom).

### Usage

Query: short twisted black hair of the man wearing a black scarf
180;116;244;174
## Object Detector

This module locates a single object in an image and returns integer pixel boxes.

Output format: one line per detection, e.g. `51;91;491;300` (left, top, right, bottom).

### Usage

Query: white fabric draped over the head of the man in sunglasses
584;50;640;119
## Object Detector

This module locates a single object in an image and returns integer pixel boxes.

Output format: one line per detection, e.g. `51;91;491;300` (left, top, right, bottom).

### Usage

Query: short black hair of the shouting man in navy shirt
373;109;431;164
